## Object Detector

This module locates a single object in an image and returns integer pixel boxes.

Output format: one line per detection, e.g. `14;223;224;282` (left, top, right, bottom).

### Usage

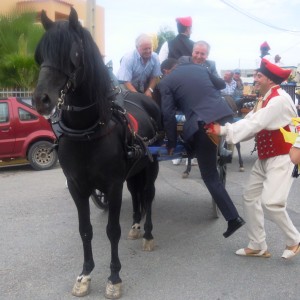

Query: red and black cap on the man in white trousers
257;58;292;84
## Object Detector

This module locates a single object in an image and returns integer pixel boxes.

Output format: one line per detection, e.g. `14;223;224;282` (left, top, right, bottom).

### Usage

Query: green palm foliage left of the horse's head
0;12;44;88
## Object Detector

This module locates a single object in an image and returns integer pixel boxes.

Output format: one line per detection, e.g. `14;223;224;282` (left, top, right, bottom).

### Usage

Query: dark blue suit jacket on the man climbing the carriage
158;63;233;148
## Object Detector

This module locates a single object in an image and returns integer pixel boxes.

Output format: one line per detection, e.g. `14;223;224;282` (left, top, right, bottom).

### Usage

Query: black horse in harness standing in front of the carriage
33;8;161;299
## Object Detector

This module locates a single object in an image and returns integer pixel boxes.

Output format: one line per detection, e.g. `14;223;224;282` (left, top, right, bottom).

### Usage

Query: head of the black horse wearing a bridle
33;8;84;116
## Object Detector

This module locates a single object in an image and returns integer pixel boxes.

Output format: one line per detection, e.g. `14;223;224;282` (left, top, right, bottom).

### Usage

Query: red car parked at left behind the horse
0;97;57;170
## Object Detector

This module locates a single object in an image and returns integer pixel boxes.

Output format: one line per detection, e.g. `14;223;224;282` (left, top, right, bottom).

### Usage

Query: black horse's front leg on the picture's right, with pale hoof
105;185;123;299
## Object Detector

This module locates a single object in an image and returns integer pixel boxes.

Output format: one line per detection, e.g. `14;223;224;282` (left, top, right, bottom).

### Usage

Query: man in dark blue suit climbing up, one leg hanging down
158;64;245;238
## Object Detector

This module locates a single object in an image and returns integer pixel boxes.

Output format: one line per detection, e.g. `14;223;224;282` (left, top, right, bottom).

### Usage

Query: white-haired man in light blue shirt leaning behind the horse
117;34;161;97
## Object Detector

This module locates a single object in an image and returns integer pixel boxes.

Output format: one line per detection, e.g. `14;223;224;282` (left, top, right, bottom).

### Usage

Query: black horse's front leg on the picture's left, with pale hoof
69;186;95;297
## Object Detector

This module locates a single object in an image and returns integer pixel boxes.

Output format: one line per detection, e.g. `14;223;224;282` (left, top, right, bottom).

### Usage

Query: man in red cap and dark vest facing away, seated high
158;17;194;63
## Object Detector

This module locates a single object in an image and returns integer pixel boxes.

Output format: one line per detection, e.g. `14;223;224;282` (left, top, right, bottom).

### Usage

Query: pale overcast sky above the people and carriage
97;0;300;71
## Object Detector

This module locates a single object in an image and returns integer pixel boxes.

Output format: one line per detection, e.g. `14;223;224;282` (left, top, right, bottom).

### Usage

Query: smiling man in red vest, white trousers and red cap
208;58;300;259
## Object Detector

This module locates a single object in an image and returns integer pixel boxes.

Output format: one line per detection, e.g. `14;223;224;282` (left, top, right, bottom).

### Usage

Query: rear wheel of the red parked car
27;141;57;171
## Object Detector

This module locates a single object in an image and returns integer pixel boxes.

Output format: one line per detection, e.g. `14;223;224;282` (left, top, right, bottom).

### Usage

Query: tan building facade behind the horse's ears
0;0;105;55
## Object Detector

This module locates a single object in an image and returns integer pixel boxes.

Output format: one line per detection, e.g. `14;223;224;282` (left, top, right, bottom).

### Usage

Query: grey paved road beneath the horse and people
0;142;300;300
